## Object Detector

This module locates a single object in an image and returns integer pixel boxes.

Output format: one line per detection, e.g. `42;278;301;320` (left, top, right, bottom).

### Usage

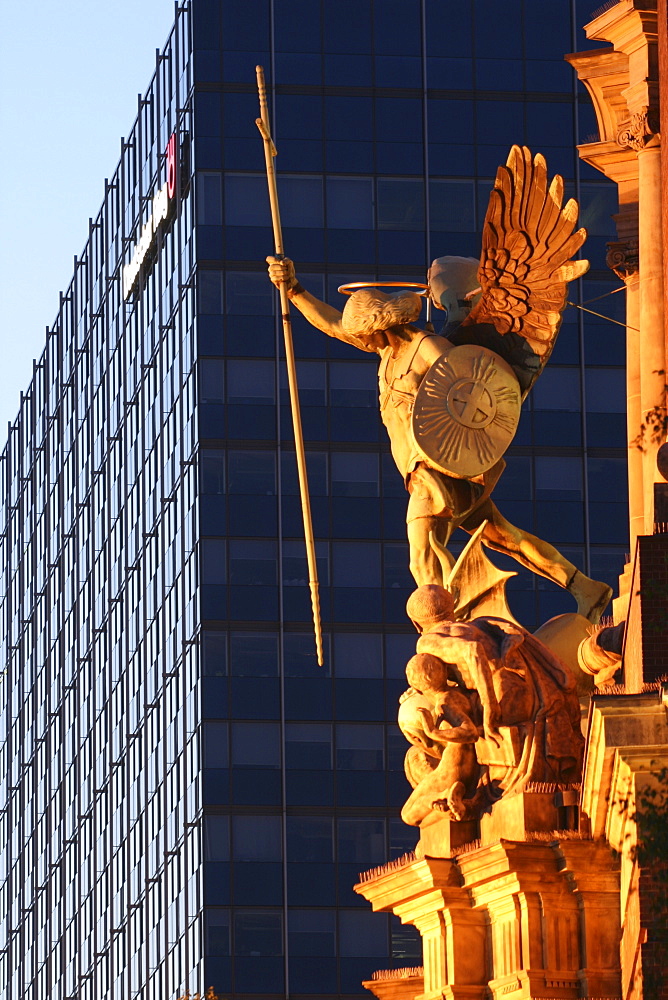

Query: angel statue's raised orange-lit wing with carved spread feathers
462;146;589;358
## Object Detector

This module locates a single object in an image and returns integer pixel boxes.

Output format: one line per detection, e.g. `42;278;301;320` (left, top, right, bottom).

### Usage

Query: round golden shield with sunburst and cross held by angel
413;344;522;479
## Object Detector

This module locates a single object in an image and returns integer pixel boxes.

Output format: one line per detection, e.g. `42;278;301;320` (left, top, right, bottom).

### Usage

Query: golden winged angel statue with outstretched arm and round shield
267;146;612;622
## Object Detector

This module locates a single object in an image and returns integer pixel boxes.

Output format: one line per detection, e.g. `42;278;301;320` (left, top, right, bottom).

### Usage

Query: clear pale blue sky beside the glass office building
0;0;174;438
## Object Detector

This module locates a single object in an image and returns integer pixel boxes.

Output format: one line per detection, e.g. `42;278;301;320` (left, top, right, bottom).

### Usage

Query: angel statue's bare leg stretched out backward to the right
462;500;612;622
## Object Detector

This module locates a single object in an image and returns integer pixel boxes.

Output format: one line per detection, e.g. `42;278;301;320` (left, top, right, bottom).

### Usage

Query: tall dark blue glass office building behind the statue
0;0;626;1000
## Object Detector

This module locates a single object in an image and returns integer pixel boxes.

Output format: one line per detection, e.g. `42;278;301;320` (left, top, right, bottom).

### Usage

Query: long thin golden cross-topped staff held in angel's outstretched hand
255;66;323;666
